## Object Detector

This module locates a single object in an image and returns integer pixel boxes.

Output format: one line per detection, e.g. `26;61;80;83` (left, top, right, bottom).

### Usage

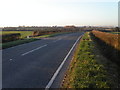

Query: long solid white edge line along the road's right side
45;36;82;90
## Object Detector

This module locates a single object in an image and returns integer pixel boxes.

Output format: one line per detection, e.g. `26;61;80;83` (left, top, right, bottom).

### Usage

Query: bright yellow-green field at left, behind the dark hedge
0;31;33;38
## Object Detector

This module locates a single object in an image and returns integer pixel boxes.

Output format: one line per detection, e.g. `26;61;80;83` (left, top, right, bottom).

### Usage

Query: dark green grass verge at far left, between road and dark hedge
0;38;38;49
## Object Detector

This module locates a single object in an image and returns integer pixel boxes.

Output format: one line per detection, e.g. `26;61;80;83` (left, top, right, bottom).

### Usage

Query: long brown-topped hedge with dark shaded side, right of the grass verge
91;30;120;66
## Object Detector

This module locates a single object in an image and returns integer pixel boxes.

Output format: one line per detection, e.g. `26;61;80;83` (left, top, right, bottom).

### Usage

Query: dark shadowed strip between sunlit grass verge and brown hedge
90;34;120;88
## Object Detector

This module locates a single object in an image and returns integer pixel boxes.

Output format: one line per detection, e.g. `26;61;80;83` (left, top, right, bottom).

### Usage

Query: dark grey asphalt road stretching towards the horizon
2;32;83;88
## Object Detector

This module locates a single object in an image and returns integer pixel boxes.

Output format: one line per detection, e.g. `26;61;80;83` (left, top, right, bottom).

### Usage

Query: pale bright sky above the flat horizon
0;0;119;27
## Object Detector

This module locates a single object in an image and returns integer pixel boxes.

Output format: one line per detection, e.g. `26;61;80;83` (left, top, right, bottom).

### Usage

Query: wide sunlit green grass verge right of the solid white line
62;33;111;88
